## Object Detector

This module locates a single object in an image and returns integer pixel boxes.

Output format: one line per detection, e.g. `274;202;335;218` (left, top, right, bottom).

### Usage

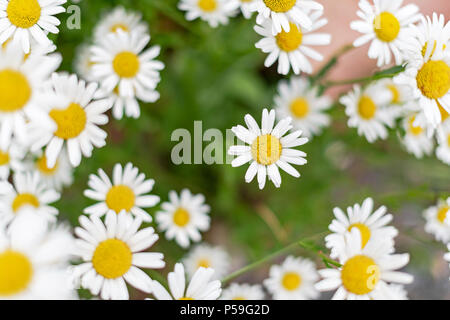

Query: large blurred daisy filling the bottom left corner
0;210;76;300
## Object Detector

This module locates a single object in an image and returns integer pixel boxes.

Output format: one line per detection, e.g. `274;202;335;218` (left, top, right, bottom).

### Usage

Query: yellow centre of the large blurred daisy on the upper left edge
0;69;32;112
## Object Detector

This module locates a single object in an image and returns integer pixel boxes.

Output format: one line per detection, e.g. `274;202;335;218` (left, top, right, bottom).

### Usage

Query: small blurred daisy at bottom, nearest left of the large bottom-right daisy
264;256;319;300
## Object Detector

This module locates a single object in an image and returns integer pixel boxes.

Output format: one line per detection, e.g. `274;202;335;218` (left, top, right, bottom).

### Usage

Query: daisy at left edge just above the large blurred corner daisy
0;172;60;222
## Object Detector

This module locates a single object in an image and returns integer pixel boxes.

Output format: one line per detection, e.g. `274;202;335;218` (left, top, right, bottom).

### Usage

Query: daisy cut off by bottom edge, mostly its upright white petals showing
151;263;222;300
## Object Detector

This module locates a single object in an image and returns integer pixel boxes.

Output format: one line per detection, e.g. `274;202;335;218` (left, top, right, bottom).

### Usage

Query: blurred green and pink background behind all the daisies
55;0;450;299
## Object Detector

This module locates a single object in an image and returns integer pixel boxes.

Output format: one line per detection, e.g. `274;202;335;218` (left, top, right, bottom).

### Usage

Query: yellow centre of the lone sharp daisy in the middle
251;134;283;166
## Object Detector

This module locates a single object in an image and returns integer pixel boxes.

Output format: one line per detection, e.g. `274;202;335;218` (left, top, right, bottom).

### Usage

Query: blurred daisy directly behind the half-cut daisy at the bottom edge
183;244;231;279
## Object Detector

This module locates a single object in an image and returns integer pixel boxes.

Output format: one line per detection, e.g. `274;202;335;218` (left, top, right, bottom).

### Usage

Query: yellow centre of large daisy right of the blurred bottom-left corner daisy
92;239;133;279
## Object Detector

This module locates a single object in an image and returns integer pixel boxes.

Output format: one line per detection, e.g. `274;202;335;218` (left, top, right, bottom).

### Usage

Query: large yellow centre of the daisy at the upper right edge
416;61;450;100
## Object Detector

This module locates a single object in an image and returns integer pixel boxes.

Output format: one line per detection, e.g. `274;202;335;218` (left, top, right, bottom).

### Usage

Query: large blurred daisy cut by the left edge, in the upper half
0;41;61;149
